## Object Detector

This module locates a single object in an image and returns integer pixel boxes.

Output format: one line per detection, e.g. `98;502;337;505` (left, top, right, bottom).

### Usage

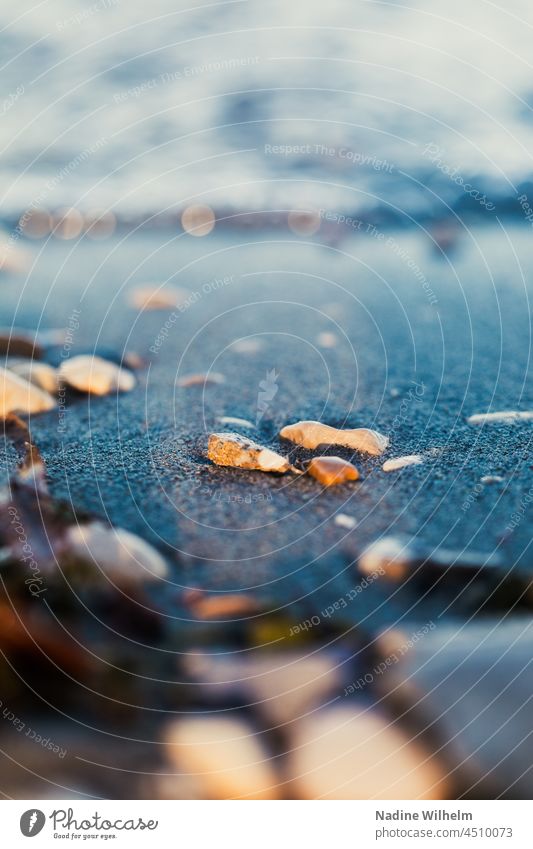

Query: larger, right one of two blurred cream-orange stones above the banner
289;705;450;799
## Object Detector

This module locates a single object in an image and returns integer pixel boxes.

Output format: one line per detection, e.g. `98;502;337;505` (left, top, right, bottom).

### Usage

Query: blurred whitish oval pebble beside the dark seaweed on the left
66;521;168;586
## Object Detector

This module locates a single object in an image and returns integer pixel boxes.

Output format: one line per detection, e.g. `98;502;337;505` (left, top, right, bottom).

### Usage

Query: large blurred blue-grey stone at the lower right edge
378;619;533;799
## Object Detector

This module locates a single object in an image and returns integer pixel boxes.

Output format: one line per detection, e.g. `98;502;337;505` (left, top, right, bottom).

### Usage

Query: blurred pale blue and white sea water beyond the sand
0;0;533;220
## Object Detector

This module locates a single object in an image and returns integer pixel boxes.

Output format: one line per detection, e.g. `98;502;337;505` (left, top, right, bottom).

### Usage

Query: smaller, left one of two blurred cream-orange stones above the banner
165;716;279;799
